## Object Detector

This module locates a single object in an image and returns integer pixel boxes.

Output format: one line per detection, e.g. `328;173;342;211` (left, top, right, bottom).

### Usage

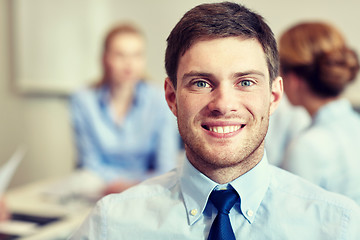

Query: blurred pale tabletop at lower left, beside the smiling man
5;172;101;240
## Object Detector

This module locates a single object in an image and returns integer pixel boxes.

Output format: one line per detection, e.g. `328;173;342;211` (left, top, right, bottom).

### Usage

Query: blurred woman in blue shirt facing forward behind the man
71;24;180;193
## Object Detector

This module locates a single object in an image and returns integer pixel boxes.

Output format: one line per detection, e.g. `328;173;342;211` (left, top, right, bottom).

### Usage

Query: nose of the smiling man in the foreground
208;86;237;115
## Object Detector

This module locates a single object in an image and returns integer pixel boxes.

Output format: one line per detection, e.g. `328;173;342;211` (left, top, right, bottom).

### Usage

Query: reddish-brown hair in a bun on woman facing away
279;22;359;97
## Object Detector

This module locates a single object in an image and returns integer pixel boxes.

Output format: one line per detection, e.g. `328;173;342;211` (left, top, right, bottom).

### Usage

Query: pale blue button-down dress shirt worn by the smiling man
71;151;360;240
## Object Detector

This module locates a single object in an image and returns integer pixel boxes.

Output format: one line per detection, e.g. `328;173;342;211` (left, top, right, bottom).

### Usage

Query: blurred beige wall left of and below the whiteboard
0;0;75;186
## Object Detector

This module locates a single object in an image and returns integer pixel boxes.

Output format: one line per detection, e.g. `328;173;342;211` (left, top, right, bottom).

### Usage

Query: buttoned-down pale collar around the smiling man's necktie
180;154;270;225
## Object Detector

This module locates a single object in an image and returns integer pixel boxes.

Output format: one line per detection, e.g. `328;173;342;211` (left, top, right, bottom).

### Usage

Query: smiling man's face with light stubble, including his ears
165;37;282;172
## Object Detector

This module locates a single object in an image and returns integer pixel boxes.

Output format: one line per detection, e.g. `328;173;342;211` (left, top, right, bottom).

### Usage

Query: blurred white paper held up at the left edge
0;147;25;196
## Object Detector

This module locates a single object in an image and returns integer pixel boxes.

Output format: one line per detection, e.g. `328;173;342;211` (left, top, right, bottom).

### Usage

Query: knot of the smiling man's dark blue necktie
210;189;239;214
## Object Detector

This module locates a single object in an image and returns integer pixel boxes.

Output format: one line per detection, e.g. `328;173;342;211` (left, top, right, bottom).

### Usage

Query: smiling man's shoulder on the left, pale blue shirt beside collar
70;171;198;239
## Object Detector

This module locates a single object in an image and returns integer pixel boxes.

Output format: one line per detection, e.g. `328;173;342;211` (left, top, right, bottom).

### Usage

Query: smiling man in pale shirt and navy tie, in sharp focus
72;2;360;240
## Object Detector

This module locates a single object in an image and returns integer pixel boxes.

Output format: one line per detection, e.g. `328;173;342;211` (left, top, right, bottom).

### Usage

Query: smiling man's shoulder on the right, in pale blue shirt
254;167;360;239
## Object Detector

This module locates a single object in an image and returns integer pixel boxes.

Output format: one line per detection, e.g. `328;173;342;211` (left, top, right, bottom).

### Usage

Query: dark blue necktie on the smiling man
208;189;239;240
